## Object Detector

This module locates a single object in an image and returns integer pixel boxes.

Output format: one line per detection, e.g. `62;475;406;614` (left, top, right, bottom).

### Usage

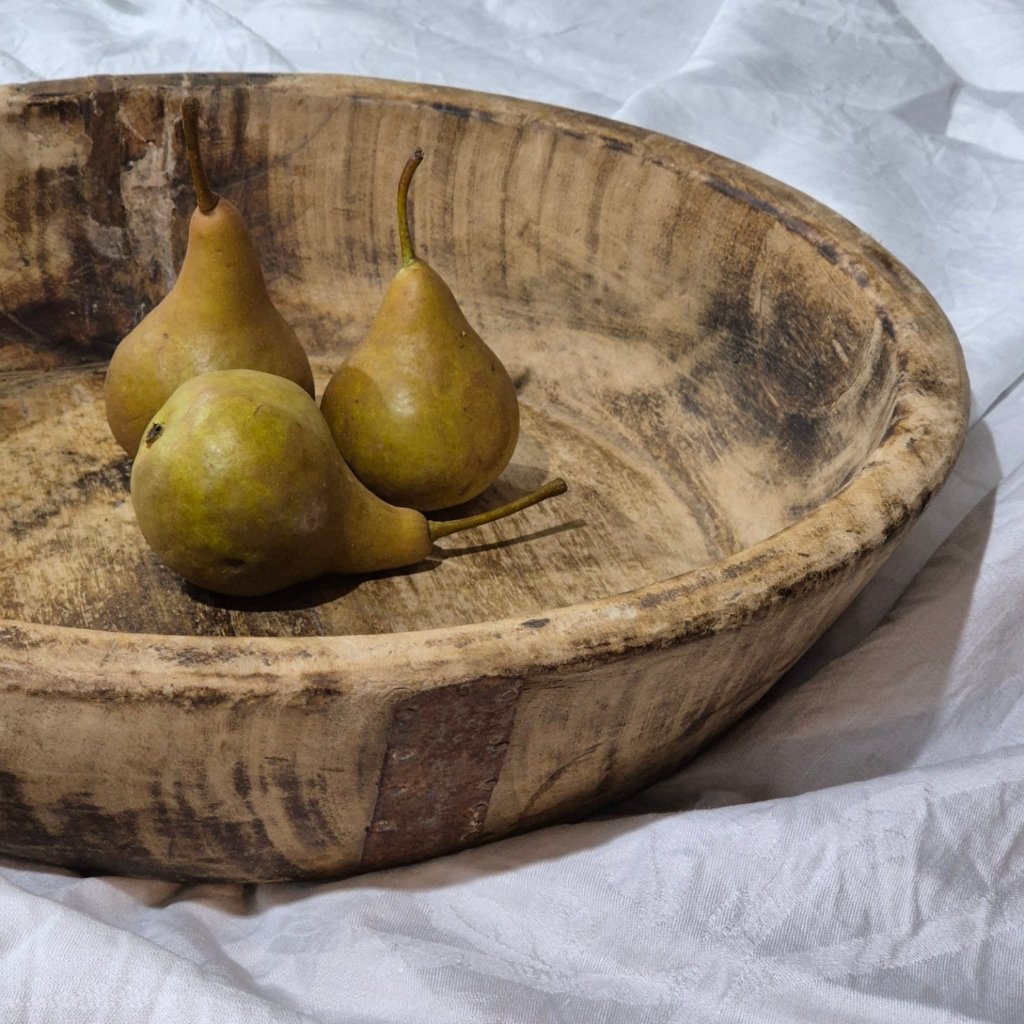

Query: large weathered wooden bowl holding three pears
0;75;968;881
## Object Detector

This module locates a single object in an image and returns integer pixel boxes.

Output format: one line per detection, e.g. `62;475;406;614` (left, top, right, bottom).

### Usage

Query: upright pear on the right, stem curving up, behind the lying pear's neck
321;150;519;511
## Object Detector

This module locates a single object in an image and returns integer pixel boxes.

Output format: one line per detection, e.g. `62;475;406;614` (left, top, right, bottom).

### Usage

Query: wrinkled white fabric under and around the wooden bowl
0;0;1024;1024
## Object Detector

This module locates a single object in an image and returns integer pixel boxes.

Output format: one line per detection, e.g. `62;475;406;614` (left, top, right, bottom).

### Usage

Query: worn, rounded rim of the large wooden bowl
0;72;970;692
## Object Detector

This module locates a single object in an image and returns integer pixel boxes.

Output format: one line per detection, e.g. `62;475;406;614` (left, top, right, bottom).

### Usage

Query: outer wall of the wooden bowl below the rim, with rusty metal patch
0;539;880;882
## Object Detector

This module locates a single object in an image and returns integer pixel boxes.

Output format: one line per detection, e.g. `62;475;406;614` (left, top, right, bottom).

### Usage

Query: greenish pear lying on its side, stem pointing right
131;370;565;597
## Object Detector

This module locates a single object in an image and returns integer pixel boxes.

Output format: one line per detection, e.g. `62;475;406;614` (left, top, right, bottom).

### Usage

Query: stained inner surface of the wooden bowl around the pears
0;76;899;635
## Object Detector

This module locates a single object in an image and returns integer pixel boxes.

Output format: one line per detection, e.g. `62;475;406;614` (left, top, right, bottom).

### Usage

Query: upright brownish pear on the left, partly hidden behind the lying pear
104;97;313;456
